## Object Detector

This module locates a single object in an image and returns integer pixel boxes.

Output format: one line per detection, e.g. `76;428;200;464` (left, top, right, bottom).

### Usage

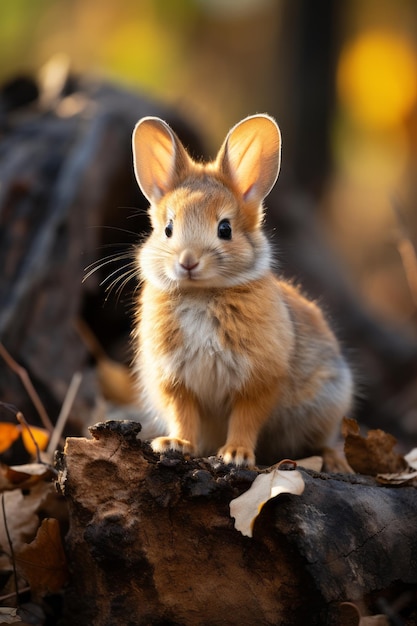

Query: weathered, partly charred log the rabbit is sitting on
59;422;417;626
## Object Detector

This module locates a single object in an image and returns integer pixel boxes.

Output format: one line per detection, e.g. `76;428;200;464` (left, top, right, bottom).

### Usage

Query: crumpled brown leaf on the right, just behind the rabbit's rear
342;418;407;476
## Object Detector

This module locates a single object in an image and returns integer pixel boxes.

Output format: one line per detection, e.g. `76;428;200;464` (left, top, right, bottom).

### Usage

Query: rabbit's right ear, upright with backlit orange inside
217;115;281;203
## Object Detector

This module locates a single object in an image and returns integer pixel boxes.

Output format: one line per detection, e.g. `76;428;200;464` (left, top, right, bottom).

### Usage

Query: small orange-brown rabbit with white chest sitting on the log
133;115;352;465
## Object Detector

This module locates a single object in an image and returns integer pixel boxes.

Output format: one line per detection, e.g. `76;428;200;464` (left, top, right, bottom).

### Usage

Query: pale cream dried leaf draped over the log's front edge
230;469;305;537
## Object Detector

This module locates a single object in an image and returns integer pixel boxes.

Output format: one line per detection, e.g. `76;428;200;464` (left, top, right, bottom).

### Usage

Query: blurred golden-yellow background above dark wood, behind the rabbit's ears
0;0;417;322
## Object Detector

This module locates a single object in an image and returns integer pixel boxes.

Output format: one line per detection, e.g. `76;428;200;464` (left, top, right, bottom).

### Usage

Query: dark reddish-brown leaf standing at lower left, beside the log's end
16;518;68;596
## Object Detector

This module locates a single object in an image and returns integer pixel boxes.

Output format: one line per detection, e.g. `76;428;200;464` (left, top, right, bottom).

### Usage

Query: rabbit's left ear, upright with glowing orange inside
132;117;190;202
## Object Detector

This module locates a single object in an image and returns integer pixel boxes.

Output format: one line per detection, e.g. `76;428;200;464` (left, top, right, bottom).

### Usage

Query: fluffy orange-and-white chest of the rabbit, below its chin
138;275;293;414
